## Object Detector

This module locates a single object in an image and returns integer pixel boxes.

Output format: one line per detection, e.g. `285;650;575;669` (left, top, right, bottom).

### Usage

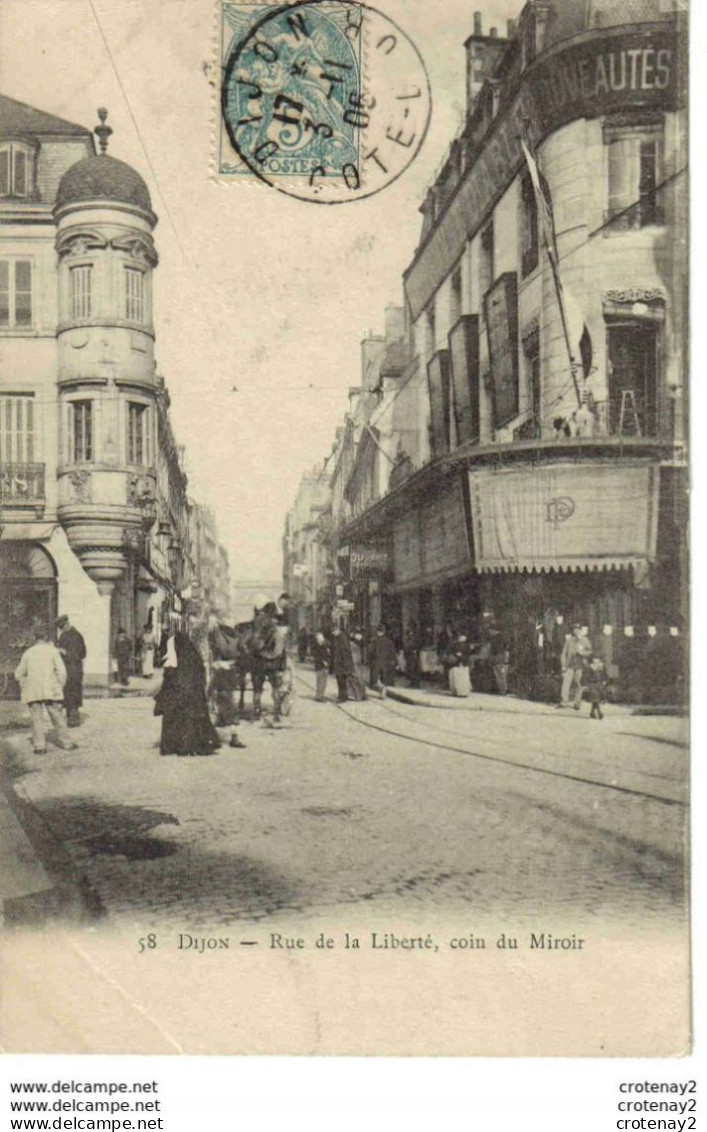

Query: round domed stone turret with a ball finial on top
54;109;157;609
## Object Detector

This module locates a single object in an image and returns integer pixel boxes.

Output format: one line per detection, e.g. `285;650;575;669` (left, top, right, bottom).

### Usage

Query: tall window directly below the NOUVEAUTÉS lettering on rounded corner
604;126;664;231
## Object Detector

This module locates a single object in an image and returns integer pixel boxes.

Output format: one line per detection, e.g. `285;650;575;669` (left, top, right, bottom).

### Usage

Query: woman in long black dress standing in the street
157;633;221;755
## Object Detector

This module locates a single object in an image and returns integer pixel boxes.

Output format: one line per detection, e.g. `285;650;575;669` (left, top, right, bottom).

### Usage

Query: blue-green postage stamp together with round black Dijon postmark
216;0;431;204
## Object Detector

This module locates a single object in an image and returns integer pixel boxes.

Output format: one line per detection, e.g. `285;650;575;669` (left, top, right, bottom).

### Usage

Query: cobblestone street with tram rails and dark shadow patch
0;667;687;933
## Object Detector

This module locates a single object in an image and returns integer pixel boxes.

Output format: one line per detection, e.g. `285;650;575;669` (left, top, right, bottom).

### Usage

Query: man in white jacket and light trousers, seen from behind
15;626;76;755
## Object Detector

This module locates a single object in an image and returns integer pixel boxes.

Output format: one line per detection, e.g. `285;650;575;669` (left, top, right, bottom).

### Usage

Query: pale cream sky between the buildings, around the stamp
0;0;521;580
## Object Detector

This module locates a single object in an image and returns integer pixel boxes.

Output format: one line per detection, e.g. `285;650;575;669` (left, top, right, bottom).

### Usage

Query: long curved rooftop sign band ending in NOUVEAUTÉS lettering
405;25;684;319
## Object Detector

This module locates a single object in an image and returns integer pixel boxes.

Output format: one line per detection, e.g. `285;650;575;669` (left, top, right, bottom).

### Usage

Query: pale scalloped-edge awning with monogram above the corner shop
469;464;658;573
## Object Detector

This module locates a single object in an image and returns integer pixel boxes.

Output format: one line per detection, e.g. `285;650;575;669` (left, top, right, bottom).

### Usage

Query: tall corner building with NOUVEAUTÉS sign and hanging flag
345;0;687;695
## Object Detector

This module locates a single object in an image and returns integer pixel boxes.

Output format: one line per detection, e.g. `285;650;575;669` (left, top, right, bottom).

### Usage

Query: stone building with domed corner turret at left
0;97;167;684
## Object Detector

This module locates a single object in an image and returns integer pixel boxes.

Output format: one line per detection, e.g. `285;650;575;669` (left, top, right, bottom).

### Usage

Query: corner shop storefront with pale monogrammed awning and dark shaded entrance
469;463;684;703
